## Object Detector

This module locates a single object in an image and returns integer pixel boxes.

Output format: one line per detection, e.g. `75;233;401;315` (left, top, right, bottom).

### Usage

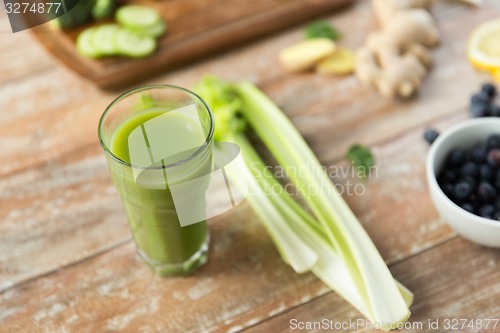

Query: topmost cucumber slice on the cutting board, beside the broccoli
115;5;162;29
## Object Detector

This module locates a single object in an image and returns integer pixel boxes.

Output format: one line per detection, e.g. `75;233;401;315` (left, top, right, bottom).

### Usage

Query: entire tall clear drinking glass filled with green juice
98;85;214;275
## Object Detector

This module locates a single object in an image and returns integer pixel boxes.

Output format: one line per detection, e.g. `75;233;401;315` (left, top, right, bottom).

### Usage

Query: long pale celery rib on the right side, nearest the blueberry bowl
235;82;410;325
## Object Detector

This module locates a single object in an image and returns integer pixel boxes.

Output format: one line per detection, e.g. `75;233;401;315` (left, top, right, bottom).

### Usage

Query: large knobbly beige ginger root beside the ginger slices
356;0;439;97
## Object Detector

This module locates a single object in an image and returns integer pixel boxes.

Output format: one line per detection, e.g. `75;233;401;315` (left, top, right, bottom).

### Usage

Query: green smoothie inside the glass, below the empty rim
108;108;212;275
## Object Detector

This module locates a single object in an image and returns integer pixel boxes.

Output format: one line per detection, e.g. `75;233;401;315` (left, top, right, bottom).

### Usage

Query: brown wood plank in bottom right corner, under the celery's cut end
246;238;500;333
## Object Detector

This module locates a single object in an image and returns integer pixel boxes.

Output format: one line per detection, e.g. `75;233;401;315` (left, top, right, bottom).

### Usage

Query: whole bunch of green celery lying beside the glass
197;77;413;329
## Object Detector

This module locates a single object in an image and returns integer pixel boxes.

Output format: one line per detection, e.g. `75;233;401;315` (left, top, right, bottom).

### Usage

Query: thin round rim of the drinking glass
97;84;215;169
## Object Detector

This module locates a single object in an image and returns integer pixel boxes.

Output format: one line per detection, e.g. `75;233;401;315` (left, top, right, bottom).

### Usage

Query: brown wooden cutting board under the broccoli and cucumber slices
32;0;353;88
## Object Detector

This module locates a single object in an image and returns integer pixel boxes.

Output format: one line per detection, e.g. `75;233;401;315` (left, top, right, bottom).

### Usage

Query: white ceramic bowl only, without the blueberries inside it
426;118;500;247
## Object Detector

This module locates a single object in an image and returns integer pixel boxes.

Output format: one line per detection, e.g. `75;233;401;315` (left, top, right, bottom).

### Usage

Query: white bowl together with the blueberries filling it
426;118;500;248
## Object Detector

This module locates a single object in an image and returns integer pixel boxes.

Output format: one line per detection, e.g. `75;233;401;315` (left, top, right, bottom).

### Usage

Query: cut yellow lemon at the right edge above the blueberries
467;19;500;73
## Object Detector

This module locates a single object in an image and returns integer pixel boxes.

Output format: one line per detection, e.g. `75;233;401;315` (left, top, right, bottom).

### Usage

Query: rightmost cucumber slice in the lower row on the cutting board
115;28;156;58
